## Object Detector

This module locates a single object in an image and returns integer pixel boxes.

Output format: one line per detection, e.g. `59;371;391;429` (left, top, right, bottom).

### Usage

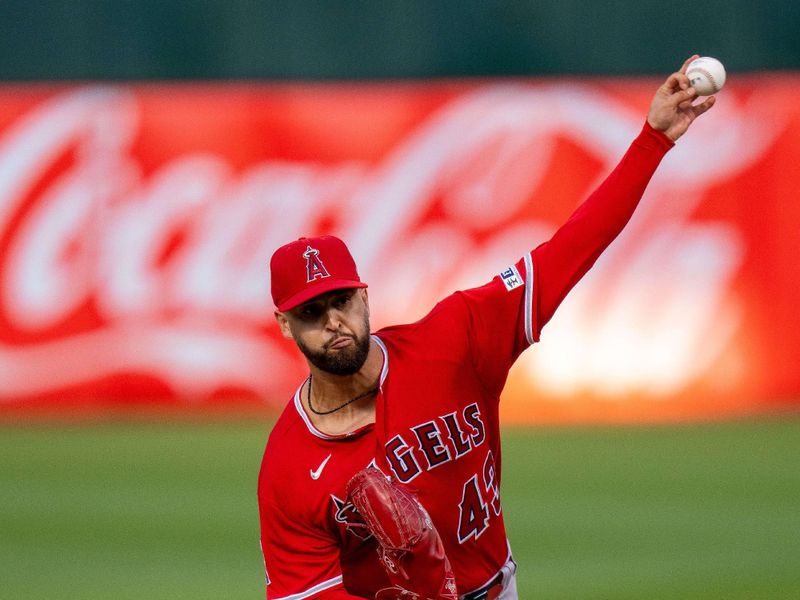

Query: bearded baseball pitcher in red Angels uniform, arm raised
258;56;714;600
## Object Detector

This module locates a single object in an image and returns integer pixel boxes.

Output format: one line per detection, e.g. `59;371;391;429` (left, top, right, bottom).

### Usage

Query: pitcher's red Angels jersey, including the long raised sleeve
259;119;672;600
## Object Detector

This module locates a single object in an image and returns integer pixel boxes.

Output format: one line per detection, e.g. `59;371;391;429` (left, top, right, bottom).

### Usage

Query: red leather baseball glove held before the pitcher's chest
347;467;458;600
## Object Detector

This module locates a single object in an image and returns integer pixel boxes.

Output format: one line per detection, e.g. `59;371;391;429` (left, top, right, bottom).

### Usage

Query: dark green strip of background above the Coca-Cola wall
0;0;800;81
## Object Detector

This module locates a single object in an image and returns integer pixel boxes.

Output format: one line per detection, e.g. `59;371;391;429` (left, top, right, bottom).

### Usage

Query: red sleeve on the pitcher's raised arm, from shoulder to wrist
460;123;674;396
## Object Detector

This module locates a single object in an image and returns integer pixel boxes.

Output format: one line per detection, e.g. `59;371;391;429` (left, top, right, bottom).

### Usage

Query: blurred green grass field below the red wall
0;416;800;600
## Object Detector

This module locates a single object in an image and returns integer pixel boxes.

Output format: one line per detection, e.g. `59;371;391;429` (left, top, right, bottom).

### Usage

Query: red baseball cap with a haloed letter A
269;235;367;312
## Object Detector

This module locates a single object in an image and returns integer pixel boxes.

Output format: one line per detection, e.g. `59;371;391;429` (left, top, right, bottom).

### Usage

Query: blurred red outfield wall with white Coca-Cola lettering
0;76;800;422
